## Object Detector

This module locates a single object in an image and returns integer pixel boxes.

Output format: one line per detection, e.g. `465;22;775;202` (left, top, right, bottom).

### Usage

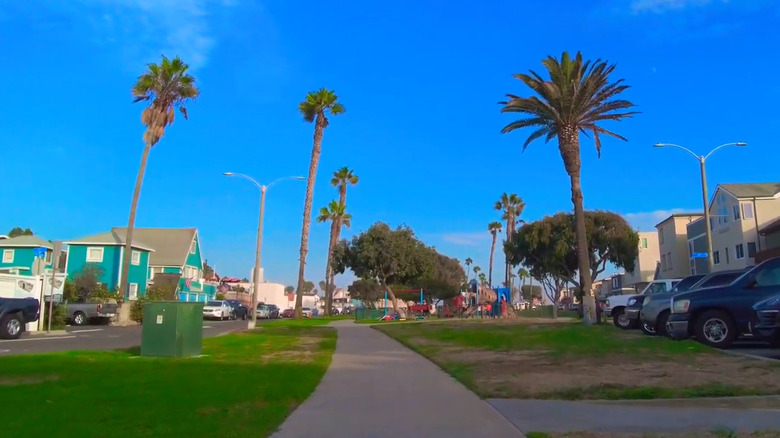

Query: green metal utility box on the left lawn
141;301;203;357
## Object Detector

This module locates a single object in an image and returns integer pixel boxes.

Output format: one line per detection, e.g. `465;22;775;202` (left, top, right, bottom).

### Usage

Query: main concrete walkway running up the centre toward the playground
273;321;524;438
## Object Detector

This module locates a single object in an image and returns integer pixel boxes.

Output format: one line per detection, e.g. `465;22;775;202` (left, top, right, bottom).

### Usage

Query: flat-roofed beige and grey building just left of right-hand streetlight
655;213;703;279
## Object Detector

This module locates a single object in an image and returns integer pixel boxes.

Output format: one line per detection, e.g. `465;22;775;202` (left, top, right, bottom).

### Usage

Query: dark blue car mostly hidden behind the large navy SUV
639;269;746;336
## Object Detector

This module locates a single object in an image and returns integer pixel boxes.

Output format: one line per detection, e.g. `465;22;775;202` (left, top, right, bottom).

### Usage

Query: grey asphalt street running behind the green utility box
0;321;246;357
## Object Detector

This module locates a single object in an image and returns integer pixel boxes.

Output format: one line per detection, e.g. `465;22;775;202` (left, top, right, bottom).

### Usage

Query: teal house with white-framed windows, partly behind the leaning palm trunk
65;230;154;300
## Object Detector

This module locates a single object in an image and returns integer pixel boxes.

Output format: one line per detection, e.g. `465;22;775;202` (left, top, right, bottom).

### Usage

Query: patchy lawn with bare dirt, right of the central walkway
374;318;780;400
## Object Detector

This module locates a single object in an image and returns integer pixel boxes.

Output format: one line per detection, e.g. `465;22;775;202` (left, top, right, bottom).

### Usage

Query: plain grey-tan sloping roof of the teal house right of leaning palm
112;227;198;266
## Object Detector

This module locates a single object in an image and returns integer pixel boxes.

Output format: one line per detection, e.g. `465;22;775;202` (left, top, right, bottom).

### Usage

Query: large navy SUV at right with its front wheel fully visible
666;257;780;348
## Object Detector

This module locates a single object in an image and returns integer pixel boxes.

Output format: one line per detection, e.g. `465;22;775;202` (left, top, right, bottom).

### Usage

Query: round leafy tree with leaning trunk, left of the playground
334;222;434;315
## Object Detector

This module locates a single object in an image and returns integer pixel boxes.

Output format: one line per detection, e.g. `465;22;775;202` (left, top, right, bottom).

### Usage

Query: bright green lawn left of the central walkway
0;320;336;438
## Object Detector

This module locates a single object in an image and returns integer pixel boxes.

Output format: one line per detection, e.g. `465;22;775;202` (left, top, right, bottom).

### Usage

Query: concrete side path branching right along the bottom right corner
489;399;780;433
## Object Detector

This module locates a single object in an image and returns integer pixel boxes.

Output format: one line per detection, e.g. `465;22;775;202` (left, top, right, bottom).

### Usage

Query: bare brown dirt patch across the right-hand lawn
409;338;780;398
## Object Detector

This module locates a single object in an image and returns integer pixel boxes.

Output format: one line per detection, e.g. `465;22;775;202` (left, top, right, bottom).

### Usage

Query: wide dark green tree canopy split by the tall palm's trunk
506;211;639;285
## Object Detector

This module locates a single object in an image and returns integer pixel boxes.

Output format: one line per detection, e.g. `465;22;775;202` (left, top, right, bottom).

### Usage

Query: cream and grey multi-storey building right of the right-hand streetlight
709;182;780;272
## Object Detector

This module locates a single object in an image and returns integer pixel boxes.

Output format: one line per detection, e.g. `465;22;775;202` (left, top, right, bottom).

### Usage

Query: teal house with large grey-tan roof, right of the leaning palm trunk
112;228;216;301
